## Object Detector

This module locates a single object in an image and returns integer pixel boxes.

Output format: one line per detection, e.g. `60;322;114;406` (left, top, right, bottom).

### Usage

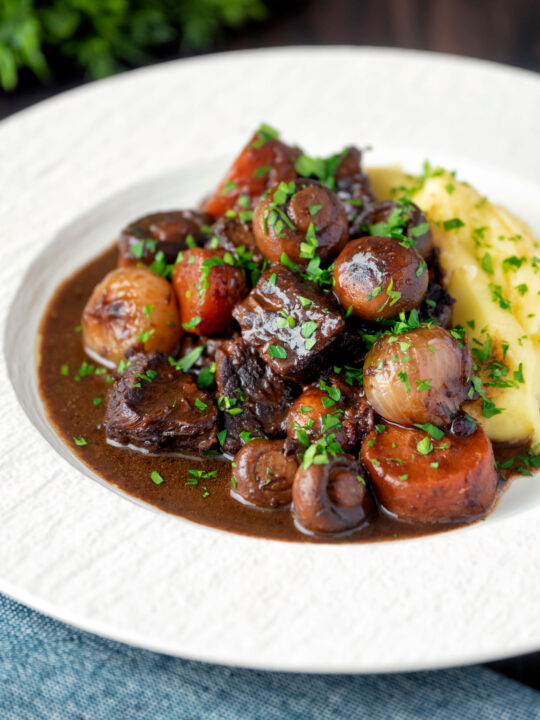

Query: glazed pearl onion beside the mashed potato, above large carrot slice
364;326;472;428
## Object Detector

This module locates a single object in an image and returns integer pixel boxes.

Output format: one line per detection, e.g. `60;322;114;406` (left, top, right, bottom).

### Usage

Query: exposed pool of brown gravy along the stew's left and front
38;247;515;543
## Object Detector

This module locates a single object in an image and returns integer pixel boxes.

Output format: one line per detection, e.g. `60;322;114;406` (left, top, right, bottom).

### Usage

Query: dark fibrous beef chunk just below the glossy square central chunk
216;339;299;454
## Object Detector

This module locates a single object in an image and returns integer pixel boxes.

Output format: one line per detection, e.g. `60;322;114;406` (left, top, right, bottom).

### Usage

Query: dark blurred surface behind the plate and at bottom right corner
0;0;540;689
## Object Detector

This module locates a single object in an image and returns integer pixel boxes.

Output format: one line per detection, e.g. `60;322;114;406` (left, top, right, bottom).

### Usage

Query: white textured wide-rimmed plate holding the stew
0;47;540;672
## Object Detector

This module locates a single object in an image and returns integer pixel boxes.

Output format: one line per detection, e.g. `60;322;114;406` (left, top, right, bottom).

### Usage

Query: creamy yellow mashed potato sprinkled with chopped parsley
369;167;540;445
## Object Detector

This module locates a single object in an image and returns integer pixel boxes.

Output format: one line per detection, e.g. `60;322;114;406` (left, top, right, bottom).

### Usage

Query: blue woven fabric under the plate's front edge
0;595;540;720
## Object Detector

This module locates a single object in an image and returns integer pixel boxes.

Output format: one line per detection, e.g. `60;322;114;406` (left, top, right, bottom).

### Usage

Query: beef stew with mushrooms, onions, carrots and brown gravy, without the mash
39;125;536;542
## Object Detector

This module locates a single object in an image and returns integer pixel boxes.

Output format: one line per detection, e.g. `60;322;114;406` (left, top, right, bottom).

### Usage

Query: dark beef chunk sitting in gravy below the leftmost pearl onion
103;353;217;452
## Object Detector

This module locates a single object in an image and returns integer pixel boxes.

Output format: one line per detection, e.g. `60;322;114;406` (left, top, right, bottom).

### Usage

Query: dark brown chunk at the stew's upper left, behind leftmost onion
118;210;212;266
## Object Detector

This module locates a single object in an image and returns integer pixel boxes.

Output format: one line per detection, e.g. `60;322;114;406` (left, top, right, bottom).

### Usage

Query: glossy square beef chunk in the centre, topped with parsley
233;264;345;383
